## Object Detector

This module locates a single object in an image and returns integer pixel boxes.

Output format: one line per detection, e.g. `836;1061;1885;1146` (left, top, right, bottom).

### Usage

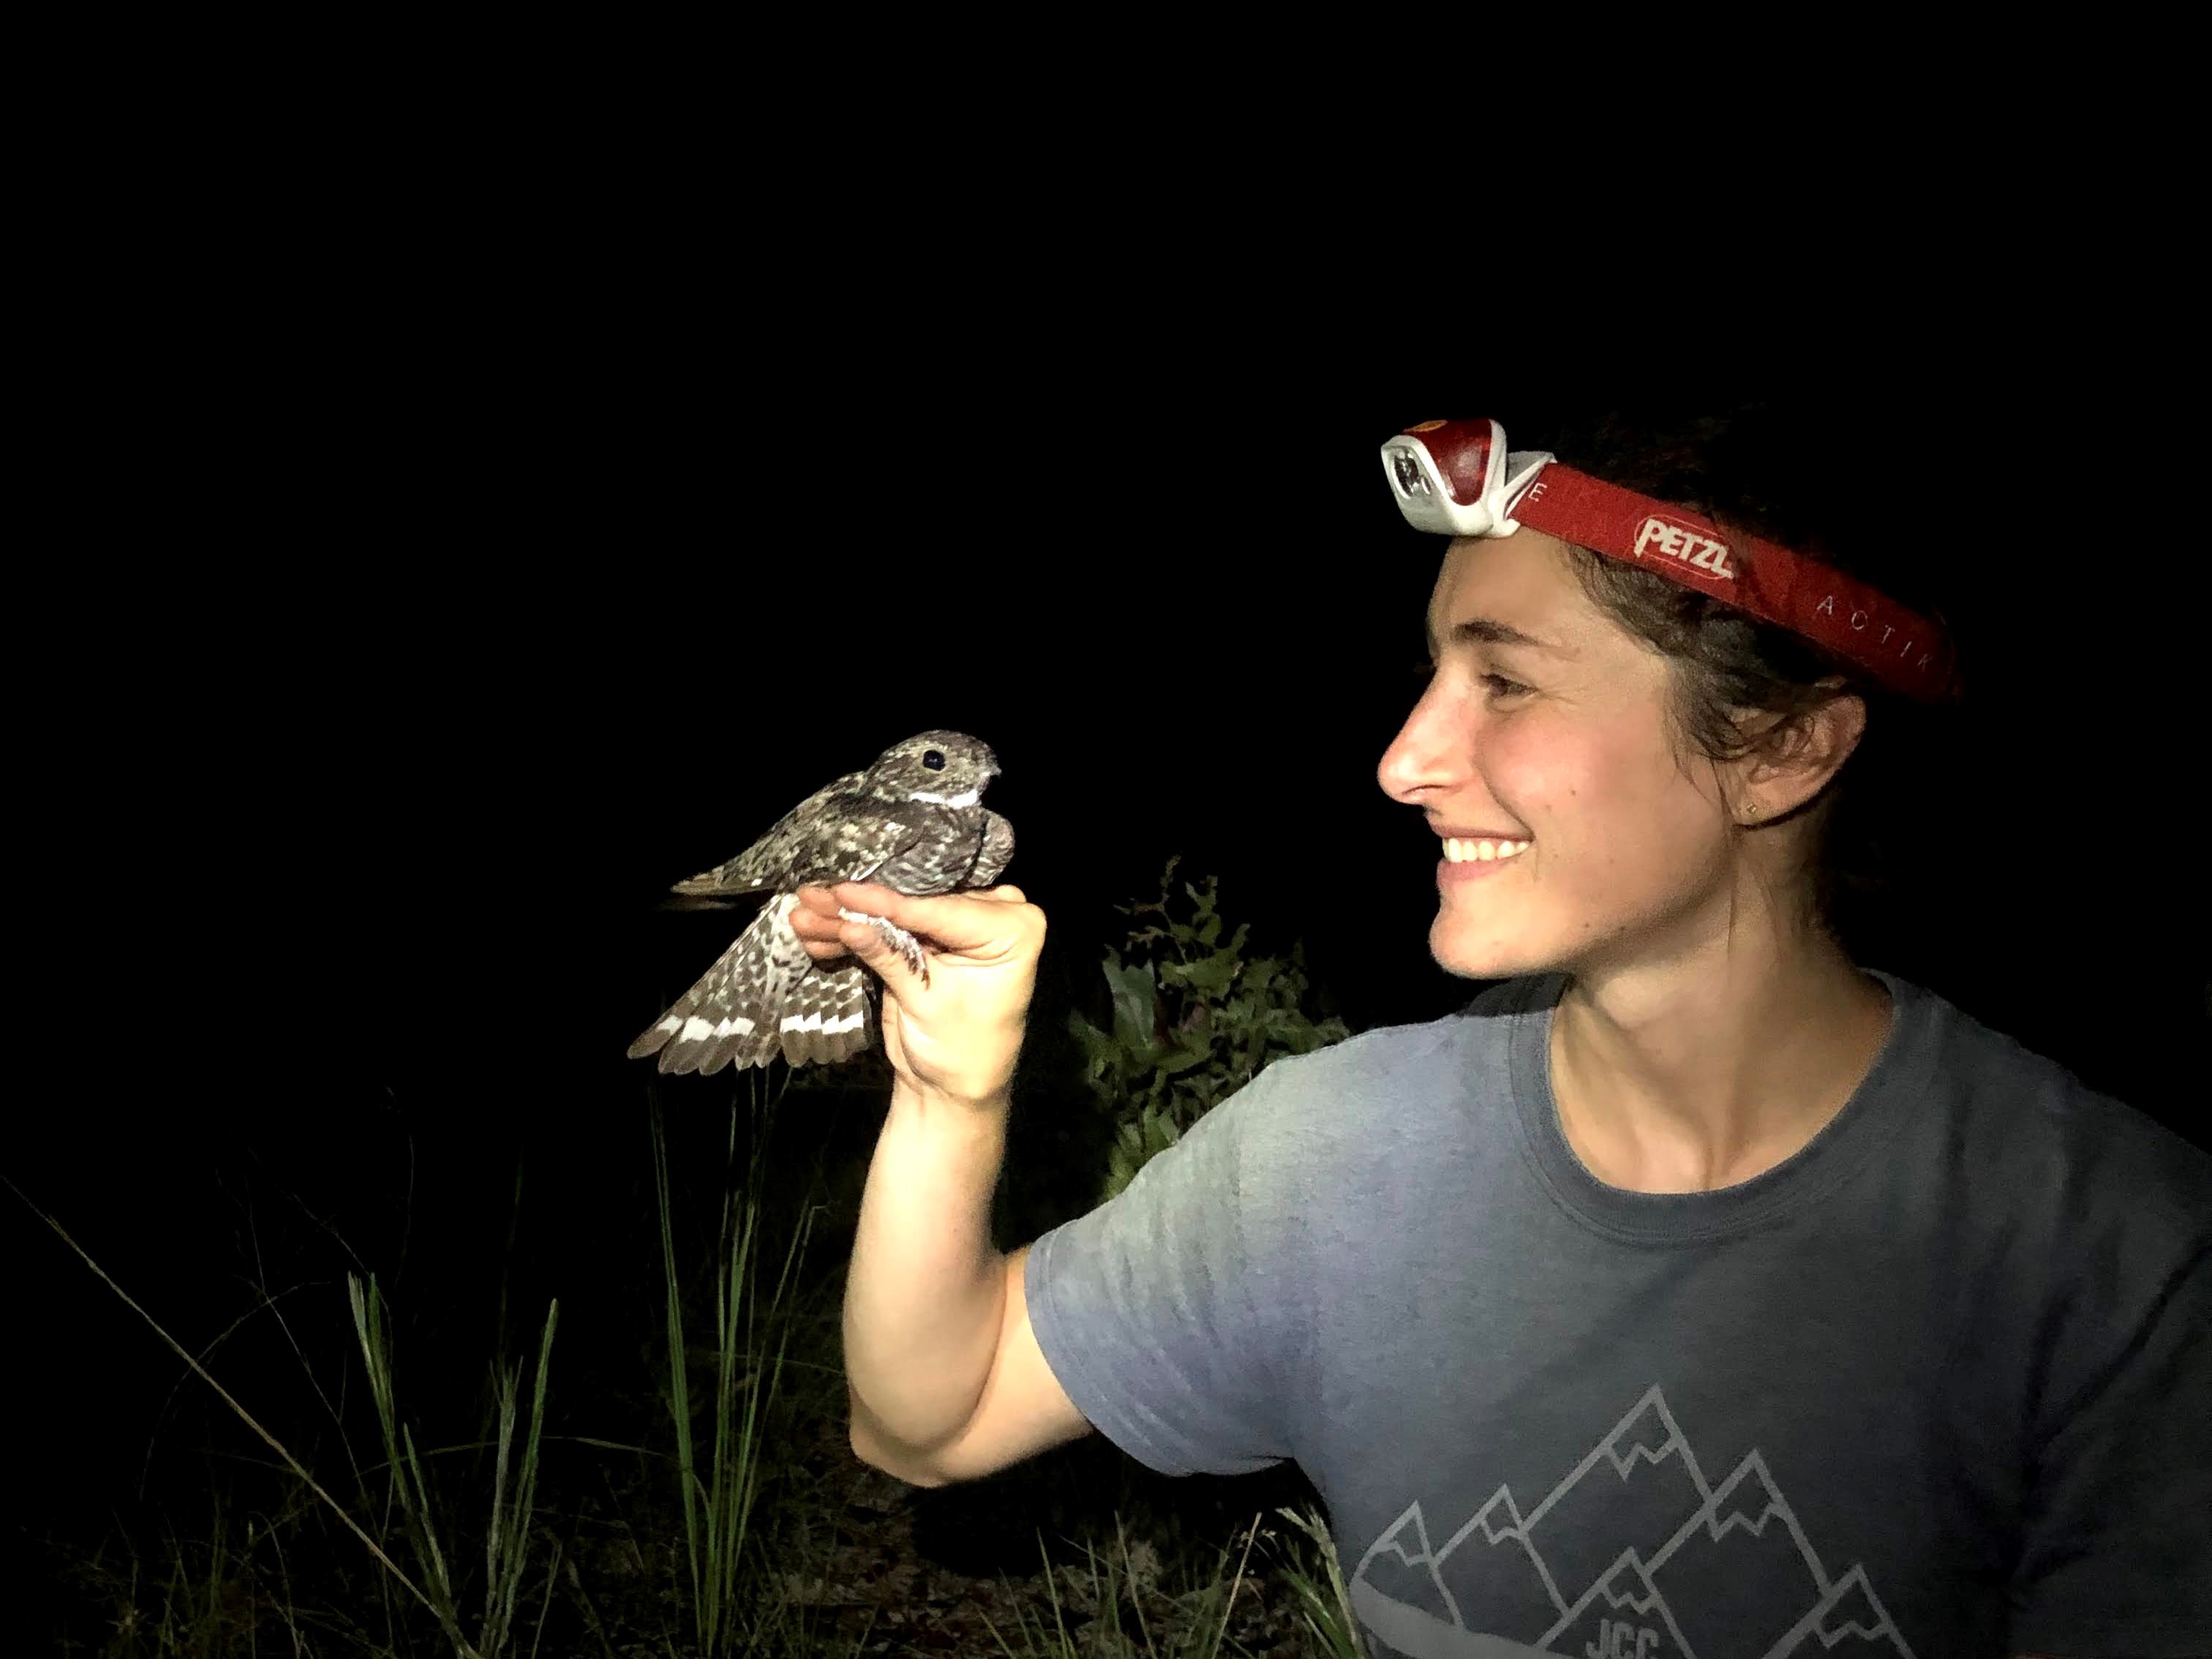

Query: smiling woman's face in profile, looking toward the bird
1378;529;1734;980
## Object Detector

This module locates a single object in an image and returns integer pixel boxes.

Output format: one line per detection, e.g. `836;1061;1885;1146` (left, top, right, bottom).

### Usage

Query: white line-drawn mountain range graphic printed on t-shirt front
1347;1385;1914;1659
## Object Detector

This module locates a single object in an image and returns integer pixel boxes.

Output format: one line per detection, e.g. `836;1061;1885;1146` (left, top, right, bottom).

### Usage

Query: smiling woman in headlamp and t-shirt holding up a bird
813;407;2212;1659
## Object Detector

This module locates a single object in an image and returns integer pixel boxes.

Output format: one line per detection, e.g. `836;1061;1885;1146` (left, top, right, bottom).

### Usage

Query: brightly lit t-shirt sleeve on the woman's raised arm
1022;1059;1305;1475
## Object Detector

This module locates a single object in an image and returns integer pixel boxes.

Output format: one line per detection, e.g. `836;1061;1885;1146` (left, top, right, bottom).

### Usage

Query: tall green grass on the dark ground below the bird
17;1095;1356;1659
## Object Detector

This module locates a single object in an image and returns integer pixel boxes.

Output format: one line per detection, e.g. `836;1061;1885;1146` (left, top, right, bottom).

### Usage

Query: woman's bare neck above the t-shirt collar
1551;936;1889;1192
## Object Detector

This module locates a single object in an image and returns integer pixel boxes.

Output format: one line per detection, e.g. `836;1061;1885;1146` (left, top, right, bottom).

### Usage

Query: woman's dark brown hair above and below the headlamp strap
1513;402;1955;955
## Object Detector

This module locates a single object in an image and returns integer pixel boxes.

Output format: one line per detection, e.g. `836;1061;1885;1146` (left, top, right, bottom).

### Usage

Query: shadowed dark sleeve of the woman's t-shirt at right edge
2011;1212;2212;1659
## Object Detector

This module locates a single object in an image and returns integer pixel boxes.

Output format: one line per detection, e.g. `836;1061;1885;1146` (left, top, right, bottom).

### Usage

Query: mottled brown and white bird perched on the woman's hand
631;732;1013;1073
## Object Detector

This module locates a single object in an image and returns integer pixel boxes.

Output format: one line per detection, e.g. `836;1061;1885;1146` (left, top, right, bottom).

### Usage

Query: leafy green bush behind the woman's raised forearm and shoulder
1069;858;1350;1201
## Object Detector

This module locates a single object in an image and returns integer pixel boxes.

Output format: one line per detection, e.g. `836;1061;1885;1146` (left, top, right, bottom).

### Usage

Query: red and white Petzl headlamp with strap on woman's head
1382;421;1957;701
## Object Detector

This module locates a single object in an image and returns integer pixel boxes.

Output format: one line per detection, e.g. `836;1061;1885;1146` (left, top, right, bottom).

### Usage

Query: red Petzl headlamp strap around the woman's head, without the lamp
1513;462;1955;701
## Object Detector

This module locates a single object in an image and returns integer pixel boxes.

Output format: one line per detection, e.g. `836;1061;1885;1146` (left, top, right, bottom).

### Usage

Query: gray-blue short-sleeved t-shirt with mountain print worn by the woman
1024;974;2212;1659
